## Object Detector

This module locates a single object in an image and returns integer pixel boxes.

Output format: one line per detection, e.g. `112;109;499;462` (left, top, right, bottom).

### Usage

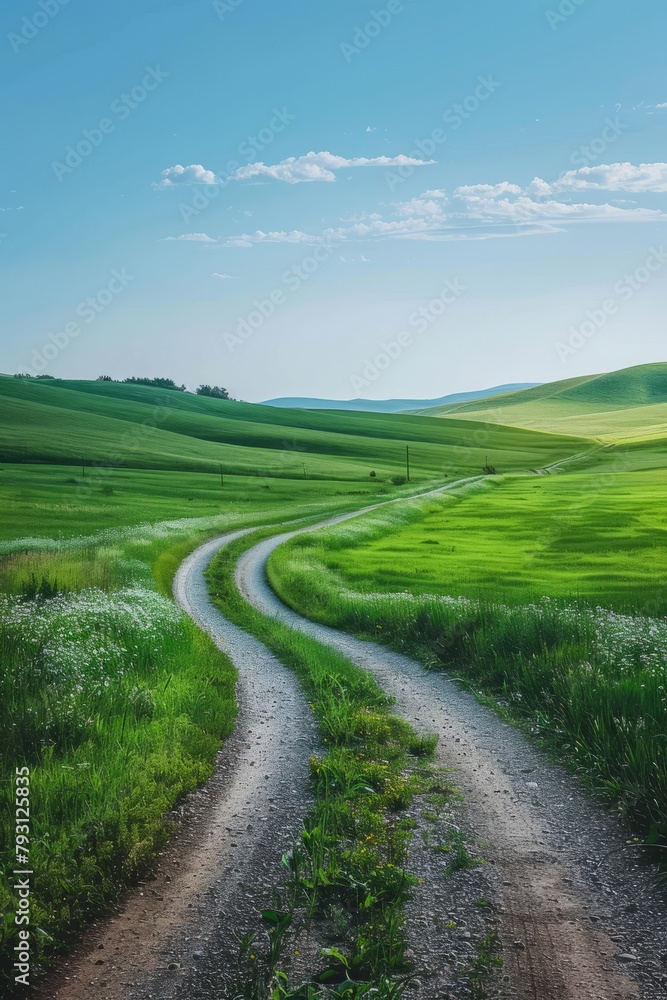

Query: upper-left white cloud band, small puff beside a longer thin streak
155;152;435;188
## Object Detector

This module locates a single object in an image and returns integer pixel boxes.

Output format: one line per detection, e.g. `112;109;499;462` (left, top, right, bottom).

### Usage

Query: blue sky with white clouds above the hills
0;0;667;400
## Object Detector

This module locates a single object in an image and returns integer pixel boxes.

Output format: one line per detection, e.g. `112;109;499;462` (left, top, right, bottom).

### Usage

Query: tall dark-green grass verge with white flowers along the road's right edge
269;528;667;835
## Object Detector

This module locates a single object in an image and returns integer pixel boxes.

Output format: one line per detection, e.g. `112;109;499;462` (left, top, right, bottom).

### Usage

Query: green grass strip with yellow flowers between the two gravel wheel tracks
207;529;444;1000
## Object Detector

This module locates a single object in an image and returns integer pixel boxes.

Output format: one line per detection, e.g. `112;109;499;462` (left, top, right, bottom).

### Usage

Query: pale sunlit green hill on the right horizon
418;362;667;440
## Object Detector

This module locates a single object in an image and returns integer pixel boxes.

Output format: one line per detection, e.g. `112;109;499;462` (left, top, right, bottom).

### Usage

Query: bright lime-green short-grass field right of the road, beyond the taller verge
294;469;667;614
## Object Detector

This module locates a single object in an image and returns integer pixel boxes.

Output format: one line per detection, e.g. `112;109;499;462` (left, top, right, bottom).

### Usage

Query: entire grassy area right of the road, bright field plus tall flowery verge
269;469;667;835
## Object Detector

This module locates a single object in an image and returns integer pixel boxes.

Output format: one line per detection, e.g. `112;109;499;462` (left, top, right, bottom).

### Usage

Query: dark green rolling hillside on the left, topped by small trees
0;376;589;480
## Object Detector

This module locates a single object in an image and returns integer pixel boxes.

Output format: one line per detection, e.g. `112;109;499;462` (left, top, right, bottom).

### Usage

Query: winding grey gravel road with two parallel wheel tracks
35;477;667;1000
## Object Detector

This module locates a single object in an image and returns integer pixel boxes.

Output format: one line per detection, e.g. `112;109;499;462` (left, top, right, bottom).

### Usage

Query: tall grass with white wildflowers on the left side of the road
0;519;245;991
